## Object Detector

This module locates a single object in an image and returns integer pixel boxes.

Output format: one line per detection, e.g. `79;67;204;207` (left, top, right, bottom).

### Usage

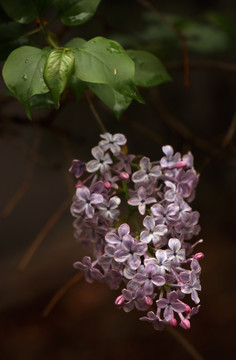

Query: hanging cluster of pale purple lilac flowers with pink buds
70;133;204;330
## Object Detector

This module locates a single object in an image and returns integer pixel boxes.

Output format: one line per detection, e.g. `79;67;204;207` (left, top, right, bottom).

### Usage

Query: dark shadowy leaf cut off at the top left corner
0;0;50;24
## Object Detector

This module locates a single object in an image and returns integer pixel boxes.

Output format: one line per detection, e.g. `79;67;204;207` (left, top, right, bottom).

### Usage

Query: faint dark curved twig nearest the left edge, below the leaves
0;131;42;218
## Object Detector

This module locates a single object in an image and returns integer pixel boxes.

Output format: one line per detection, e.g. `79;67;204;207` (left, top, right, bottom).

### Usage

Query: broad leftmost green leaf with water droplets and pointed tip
2;46;48;119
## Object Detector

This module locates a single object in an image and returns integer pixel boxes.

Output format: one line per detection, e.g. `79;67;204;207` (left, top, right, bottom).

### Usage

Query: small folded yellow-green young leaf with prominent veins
43;49;75;109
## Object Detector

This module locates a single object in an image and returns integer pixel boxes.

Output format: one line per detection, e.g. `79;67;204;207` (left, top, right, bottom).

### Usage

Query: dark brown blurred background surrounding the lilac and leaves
0;0;236;360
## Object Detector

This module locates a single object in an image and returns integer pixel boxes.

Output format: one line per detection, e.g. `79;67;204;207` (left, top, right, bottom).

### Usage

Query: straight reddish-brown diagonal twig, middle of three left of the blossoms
18;199;70;271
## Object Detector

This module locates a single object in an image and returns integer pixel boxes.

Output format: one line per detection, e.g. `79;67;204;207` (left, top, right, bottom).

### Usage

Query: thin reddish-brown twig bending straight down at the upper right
137;0;189;87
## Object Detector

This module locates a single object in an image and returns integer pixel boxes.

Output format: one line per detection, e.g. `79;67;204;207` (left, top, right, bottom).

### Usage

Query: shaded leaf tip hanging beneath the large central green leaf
88;84;132;118
